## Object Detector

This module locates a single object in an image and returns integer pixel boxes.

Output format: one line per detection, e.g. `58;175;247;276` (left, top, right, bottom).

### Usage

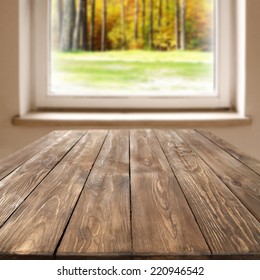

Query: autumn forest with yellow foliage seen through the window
51;0;214;51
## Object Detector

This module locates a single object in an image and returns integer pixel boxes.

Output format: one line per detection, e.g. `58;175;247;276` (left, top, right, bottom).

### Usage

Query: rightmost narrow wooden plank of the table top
196;130;260;175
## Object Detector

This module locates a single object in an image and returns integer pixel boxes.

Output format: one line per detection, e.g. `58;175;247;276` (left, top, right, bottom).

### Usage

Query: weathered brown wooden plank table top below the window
0;129;260;259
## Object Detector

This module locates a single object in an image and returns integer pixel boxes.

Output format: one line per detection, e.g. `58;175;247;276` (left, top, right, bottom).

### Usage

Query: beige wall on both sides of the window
0;0;260;159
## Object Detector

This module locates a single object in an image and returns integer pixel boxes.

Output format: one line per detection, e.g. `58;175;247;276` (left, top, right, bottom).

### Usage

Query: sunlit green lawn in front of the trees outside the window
51;50;214;95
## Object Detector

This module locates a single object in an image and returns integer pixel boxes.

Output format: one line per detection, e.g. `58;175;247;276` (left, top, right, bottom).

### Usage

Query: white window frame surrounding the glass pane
32;0;236;109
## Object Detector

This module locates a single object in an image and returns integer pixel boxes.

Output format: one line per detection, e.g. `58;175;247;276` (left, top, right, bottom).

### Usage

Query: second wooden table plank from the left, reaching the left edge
0;131;84;227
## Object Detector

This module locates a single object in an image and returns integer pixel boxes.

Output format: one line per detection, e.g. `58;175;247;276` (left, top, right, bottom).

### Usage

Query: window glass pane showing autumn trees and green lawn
49;0;216;96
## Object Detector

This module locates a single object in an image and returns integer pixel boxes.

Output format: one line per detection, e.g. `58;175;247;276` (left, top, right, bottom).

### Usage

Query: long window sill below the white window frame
12;112;251;128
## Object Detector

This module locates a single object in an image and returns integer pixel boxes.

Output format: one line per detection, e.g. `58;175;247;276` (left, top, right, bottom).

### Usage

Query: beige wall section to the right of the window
208;0;260;159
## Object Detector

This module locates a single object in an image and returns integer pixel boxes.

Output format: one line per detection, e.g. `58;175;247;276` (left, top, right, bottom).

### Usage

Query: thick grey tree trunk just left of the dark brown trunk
61;0;75;51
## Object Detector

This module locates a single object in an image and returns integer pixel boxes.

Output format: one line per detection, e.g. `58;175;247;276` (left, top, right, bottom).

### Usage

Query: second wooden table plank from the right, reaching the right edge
178;130;260;221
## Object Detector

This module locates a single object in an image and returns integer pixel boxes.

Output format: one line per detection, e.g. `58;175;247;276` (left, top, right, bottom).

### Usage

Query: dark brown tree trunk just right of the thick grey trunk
72;0;86;50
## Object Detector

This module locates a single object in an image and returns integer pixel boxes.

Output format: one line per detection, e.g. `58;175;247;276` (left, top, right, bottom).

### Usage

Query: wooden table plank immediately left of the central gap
57;130;131;257
